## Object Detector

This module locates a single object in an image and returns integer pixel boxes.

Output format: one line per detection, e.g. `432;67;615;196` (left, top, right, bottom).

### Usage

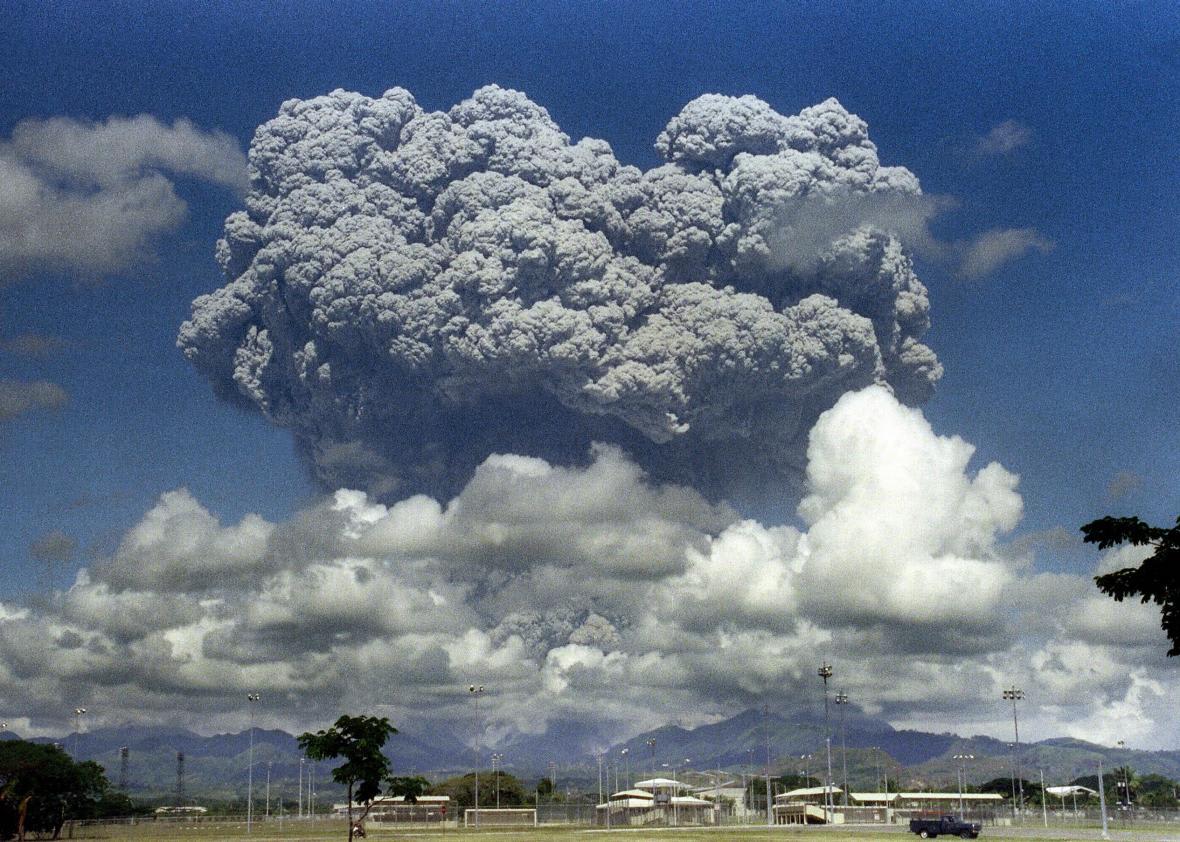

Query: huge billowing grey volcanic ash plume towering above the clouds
178;86;942;499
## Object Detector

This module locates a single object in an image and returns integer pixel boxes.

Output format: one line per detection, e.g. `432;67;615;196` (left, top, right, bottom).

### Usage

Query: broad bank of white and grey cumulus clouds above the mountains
0;387;1180;739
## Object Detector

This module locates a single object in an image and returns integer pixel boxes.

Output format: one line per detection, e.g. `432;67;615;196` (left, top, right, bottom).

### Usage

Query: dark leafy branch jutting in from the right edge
1082;517;1180;658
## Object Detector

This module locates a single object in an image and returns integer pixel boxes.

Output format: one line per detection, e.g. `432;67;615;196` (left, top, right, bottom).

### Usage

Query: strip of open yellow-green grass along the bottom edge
73;821;1180;842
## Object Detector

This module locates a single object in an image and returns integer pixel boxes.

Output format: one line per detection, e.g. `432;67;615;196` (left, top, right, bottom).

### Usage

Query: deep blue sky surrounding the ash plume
0;2;1180;735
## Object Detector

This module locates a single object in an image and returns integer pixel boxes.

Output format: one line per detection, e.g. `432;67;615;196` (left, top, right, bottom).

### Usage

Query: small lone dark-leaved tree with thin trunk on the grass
299;715;398;842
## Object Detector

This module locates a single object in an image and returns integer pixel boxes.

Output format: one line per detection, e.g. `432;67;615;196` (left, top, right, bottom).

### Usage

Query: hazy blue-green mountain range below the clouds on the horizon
0;710;1180;802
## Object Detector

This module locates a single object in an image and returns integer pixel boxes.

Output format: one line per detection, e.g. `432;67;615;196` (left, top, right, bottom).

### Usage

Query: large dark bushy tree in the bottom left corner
0;739;110;840
